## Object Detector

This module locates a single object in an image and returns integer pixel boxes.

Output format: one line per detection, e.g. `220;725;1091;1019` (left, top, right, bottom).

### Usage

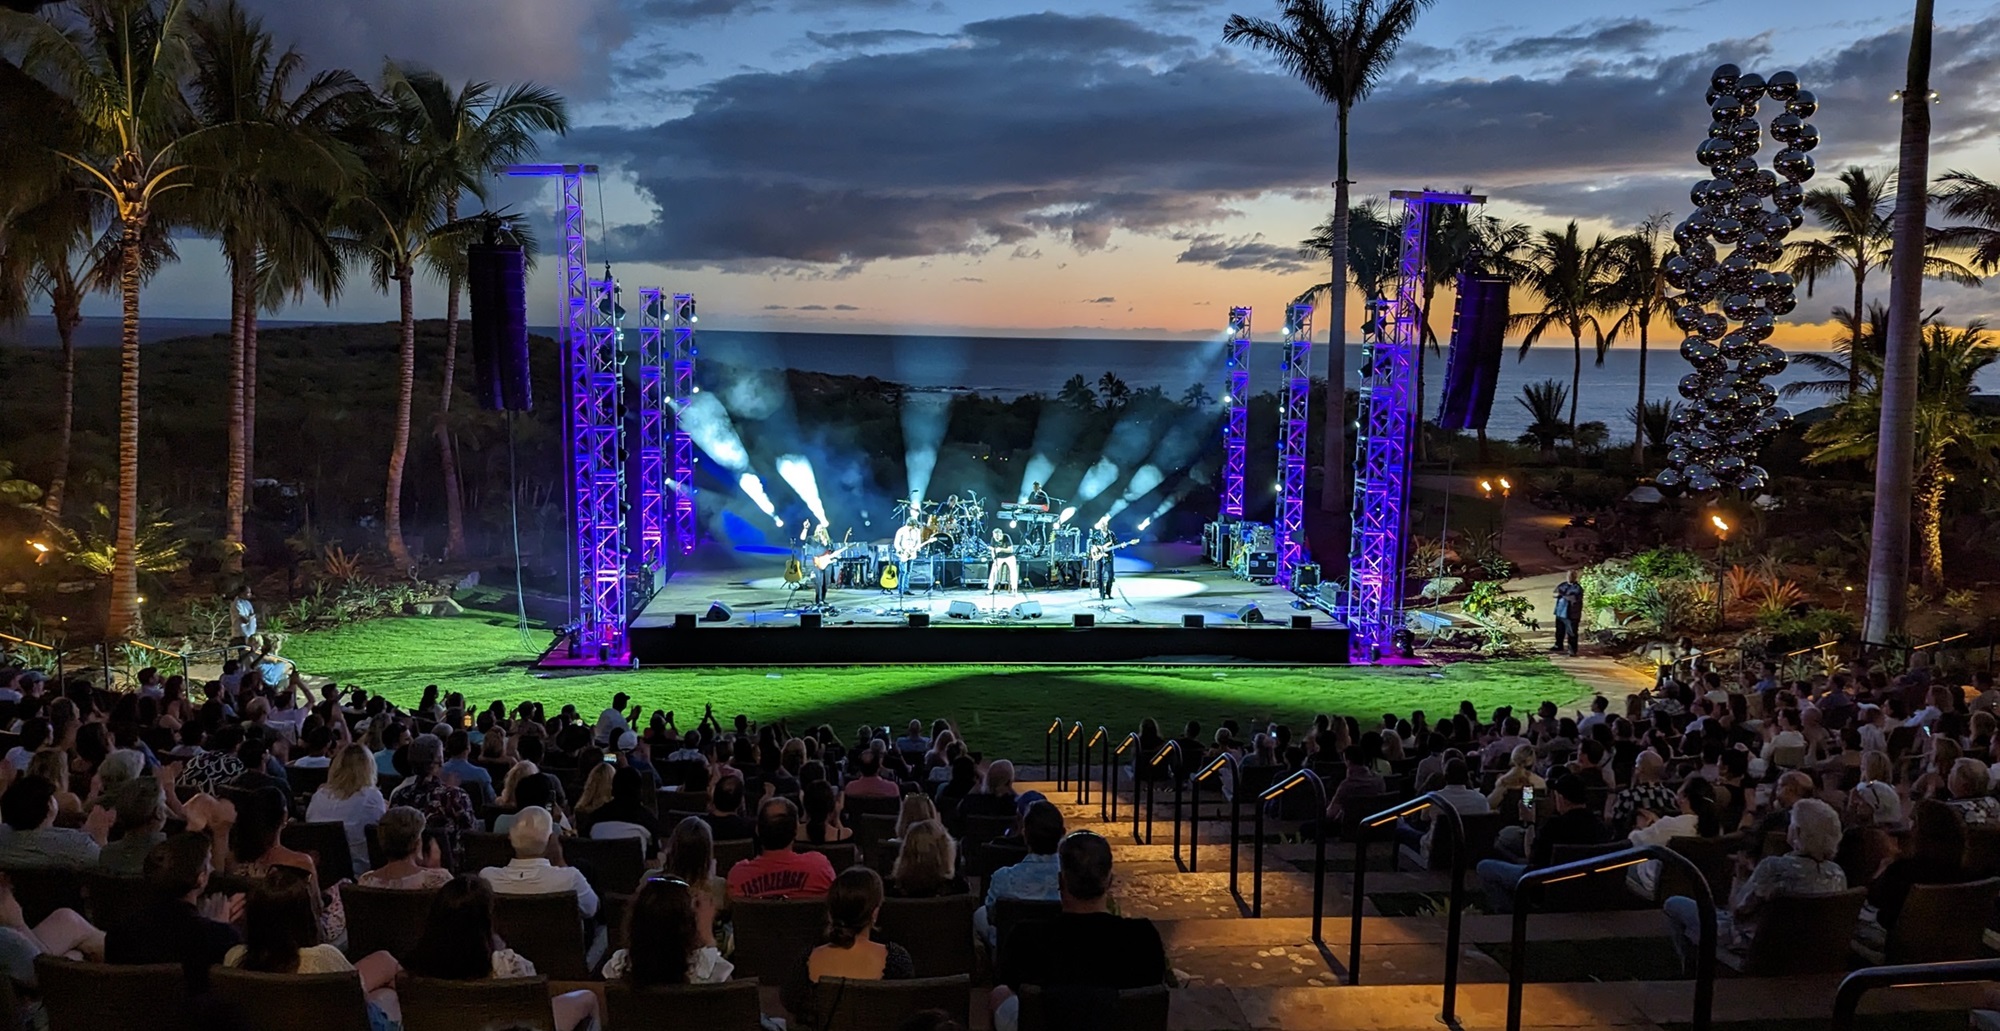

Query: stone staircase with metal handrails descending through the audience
1016;781;1980;1031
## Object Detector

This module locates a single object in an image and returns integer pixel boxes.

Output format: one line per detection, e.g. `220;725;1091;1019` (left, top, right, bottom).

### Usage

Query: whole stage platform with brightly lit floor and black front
632;543;1348;665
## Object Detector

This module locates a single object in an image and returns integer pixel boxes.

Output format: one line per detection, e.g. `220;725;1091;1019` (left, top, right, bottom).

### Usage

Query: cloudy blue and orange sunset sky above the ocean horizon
105;0;2000;344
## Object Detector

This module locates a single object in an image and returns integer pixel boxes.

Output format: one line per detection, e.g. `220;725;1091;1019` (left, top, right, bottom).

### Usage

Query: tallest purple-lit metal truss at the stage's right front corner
1334;190;1484;659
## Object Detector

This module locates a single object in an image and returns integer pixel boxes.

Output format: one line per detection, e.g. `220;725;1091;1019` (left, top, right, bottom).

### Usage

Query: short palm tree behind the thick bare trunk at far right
1806;322;2000;589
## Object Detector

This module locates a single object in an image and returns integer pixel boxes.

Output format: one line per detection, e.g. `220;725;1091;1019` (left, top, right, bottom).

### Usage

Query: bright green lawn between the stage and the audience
284;613;1584;757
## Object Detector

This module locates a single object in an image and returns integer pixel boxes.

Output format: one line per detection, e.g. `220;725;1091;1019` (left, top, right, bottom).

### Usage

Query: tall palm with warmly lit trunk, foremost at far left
0;0;208;635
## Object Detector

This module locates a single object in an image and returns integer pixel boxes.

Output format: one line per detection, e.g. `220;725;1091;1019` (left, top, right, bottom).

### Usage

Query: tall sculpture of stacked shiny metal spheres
1654;64;1820;494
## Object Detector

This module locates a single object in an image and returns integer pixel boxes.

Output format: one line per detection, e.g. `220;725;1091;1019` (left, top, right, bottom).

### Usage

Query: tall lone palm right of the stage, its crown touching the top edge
1222;0;1432;512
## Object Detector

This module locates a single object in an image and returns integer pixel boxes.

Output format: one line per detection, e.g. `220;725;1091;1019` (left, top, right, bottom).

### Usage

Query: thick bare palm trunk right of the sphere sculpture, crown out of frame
1856;0;1934;643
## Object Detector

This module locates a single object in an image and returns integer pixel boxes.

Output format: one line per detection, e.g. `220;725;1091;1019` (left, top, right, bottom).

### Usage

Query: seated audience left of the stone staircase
0;669;1170;1031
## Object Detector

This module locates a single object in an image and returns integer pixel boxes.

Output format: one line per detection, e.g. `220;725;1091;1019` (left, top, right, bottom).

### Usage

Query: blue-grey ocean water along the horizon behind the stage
0;318;1872;442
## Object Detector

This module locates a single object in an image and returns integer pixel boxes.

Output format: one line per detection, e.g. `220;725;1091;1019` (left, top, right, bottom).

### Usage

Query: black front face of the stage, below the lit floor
632;617;1348;665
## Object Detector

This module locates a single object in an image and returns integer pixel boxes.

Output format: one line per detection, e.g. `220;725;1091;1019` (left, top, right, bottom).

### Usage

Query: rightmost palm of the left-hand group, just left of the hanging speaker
384;66;570;557
